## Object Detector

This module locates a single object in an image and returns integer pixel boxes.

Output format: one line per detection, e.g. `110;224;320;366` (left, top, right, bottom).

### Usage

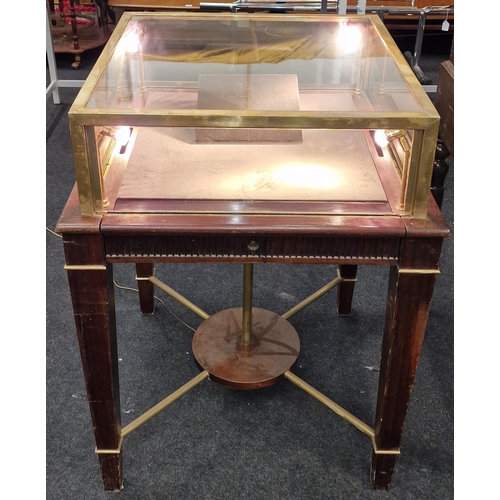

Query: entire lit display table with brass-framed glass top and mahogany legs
56;13;449;491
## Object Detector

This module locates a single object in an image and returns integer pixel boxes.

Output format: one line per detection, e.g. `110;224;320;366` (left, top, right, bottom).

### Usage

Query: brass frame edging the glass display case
69;12;440;218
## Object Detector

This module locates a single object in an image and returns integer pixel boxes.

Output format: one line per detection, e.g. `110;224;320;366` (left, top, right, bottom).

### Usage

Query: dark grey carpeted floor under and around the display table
46;22;454;500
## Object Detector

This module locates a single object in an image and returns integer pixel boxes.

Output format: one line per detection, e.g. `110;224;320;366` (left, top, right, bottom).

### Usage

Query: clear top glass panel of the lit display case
87;16;421;113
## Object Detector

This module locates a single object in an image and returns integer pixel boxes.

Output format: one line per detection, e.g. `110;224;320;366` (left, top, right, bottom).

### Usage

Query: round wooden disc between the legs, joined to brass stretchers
193;307;300;389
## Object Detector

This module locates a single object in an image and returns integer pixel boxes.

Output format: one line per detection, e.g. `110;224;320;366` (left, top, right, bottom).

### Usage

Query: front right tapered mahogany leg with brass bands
371;236;441;489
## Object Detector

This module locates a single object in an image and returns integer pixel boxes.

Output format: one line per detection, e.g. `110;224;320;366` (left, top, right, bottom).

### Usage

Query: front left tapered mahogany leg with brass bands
63;234;122;491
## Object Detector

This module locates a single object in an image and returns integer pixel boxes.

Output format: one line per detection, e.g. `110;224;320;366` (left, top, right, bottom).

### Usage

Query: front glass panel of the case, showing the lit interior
97;127;411;213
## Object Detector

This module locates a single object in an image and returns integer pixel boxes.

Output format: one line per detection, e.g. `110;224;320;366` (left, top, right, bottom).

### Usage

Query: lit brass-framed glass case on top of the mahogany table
69;13;439;218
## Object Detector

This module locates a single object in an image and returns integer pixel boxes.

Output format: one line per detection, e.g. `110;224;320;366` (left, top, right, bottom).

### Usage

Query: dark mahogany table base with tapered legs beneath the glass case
57;189;449;491
